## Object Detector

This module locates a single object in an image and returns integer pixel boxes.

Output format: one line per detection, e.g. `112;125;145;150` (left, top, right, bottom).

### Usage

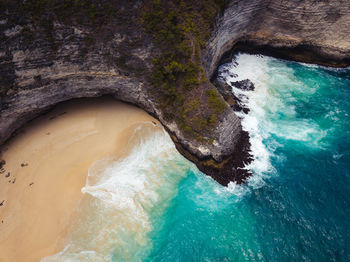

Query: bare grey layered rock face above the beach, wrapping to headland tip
0;6;245;184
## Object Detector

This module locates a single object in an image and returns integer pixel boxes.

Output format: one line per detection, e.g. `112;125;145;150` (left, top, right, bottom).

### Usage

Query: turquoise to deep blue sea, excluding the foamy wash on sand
148;55;350;261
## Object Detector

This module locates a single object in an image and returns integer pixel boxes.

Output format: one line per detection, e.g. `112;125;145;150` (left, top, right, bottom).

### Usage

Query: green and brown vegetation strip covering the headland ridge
142;0;226;140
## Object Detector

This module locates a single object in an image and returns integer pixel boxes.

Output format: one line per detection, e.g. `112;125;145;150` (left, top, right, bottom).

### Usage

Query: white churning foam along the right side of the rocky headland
219;53;327;192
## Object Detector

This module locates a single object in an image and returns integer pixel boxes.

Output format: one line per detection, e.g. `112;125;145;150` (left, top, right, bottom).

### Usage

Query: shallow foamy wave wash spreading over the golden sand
42;124;194;262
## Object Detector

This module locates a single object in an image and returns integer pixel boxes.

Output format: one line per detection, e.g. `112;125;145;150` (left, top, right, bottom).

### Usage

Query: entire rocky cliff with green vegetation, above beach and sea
0;0;350;185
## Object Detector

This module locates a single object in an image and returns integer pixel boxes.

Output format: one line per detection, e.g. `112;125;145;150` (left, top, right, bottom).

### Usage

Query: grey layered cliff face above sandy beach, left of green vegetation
0;5;155;143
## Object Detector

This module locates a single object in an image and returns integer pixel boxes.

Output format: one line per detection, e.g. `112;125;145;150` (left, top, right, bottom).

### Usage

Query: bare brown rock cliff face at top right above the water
205;0;350;76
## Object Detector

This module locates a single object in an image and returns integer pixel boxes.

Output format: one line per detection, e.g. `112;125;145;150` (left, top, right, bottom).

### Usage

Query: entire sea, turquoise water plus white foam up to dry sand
42;54;350;262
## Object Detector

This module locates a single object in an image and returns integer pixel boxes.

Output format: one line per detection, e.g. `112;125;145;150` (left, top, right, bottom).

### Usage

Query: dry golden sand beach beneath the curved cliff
0;98;159;262
